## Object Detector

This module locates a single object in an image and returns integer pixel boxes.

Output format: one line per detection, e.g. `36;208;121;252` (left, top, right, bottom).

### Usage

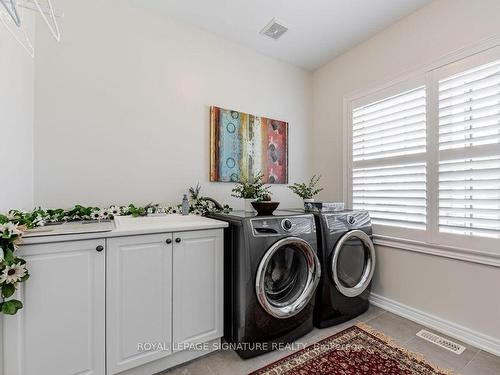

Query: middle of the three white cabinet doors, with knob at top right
106;234;172;374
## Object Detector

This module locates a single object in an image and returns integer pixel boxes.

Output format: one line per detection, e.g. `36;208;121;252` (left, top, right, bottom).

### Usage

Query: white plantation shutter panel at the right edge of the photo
439;60;500;238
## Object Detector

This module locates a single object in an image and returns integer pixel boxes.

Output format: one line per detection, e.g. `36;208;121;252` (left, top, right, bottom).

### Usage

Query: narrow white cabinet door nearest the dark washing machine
173;229;223;348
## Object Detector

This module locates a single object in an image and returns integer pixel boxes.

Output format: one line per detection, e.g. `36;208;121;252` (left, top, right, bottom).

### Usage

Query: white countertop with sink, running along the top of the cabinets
22;214;228;245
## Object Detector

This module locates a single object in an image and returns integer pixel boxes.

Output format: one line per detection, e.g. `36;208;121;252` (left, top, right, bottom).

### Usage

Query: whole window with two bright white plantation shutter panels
347;47;500;248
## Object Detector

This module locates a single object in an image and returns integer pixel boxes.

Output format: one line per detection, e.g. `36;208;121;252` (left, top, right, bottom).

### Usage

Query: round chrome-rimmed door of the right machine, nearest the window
331;230;375;297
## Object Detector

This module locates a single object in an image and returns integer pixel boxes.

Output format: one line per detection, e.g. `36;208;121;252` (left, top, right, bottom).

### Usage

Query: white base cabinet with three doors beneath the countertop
0;229;223;375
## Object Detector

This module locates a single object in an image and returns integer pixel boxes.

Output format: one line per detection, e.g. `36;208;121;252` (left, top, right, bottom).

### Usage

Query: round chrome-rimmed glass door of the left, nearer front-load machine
255;237;321;319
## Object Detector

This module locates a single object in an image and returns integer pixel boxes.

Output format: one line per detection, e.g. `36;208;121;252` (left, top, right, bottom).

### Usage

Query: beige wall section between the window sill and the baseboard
373;246;500;344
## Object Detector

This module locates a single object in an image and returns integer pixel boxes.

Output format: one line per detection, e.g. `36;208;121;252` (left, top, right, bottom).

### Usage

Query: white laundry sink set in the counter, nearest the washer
114;214;227;231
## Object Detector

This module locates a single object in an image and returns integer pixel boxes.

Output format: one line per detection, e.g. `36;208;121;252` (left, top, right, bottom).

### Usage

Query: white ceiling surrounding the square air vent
136;0;431;70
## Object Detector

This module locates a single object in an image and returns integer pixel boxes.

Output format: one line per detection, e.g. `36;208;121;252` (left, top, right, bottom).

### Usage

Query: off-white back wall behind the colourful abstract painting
35;0;312;212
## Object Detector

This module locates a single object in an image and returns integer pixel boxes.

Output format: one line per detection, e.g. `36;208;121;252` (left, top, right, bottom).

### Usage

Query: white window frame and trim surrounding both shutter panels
343;36;500;266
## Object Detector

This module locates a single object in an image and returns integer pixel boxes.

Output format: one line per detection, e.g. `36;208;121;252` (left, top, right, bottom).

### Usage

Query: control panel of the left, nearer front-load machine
250;215;316;237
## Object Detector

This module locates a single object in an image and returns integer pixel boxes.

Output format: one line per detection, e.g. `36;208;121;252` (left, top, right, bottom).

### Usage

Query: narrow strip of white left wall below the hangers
0;14;34;212
